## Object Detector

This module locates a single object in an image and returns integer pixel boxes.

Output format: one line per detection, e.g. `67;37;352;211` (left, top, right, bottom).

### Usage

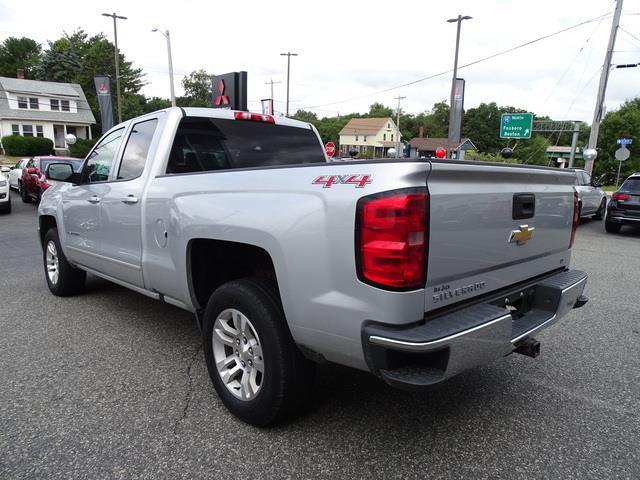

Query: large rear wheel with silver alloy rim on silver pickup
202;278;315;427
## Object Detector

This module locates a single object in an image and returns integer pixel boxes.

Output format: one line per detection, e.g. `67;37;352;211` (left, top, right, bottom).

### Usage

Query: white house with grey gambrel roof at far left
0;77;96;153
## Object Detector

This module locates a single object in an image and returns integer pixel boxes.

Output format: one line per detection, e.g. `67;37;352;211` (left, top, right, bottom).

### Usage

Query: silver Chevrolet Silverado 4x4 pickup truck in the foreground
39;108;587;426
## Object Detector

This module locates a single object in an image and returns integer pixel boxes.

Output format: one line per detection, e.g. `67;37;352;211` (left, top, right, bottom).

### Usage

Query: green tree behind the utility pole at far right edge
593;97;640;180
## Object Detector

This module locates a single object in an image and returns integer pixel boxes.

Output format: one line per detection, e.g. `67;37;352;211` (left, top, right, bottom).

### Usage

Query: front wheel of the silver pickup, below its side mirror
42;228;87;297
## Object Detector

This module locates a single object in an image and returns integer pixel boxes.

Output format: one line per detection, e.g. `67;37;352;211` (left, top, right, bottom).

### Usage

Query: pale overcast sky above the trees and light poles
0;0;640;123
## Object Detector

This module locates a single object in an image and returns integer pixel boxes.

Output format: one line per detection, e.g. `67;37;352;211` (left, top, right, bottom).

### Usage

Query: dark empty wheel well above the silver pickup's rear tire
187;239;277;308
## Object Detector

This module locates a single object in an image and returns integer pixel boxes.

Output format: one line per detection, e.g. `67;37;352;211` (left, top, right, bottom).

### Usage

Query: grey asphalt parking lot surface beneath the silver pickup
0;194;640;479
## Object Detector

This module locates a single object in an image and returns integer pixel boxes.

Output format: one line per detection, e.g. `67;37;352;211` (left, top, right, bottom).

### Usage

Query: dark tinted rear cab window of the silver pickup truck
167;117;326;174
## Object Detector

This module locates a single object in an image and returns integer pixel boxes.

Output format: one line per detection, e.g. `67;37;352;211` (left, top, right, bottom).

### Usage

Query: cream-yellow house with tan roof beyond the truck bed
340;118;401;158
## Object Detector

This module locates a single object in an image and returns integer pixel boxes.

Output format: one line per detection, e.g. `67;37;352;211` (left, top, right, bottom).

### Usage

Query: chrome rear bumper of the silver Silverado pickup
362;270;587;388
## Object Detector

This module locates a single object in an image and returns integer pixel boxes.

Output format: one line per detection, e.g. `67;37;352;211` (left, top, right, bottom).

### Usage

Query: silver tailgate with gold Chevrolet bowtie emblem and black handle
425;161;574;311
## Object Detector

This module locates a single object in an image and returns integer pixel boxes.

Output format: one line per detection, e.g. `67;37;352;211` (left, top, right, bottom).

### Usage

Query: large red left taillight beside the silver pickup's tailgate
356;193;428;290
